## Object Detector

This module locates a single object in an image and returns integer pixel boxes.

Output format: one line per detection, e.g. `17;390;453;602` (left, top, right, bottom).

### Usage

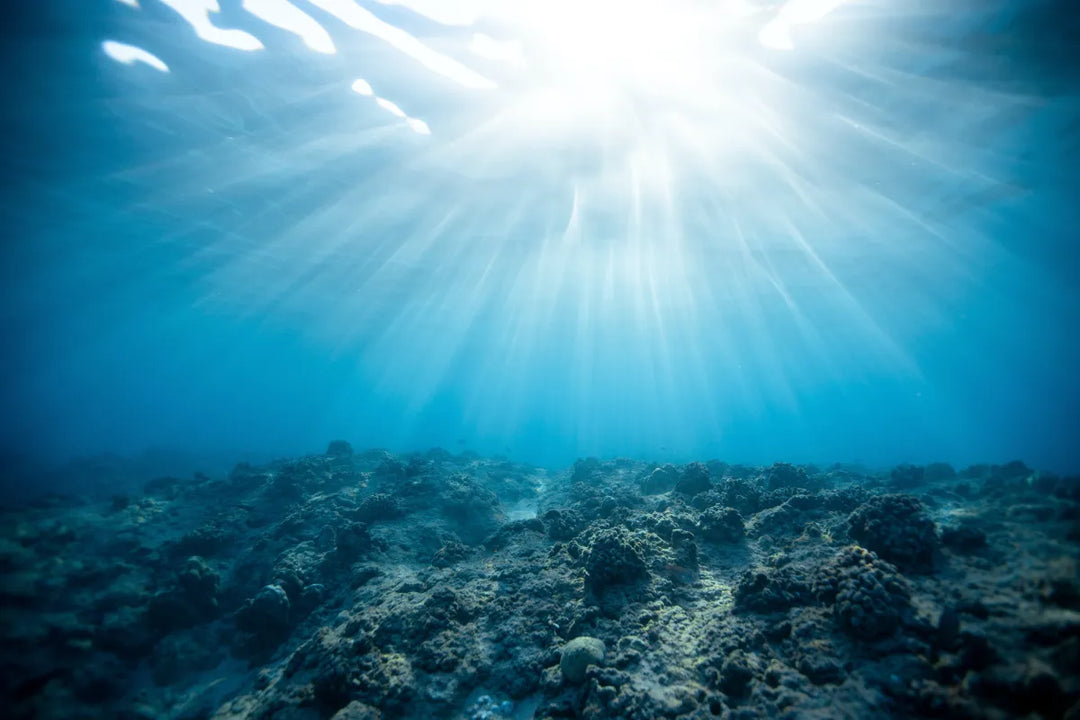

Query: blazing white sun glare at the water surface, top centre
447;0;851;182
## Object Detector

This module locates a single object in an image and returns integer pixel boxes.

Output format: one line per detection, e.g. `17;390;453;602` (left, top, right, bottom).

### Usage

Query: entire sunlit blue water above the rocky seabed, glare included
0;0;1080;472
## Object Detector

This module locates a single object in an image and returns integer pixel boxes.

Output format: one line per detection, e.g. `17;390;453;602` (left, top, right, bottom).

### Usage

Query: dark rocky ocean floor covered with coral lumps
0;441;1080;720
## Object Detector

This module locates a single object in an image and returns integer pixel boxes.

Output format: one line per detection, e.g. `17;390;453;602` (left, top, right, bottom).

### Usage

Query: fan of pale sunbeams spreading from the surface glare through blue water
78;0;1071;464
